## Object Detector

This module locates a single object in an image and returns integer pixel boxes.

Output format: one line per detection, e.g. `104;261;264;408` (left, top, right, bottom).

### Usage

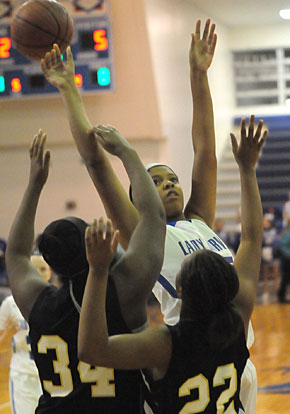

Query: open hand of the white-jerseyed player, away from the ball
189;19;217;72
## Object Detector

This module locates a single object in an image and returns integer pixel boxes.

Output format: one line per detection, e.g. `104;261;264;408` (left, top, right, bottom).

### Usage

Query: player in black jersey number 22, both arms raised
78;116;267;414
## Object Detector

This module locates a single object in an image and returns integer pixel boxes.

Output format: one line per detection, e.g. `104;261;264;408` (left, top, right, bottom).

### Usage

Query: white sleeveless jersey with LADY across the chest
153;219;254;348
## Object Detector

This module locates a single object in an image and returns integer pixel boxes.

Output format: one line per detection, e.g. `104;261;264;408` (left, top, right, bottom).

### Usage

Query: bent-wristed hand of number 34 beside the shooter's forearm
93;125;130;156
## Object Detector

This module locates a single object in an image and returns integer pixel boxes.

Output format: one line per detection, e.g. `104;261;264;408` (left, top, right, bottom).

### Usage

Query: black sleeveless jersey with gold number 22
151;321;249;414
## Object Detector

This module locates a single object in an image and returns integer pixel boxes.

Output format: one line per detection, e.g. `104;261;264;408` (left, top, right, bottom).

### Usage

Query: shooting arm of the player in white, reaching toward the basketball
41;45;138;249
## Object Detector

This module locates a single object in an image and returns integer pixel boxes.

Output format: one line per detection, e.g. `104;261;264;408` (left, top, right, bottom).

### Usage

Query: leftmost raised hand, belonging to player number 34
29;129;50;188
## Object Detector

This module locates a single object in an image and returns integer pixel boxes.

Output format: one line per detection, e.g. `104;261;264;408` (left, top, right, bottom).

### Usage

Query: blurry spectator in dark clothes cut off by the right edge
278;217;290;303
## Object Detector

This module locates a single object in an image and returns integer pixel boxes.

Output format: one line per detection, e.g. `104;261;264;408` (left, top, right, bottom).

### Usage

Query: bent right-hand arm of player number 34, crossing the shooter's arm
95;126;166;320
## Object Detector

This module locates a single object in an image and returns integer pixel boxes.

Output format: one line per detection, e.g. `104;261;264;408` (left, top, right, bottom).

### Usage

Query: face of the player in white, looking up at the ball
149;166;183;221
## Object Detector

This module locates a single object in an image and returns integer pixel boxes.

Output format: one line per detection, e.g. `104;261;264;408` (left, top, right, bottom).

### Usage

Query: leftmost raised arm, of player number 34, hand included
5;130;50;321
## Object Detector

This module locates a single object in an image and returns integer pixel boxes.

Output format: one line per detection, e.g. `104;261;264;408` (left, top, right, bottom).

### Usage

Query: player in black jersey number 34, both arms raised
6;127;165;414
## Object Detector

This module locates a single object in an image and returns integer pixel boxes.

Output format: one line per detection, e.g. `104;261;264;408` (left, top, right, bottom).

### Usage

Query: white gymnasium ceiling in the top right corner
191;0;290;26
